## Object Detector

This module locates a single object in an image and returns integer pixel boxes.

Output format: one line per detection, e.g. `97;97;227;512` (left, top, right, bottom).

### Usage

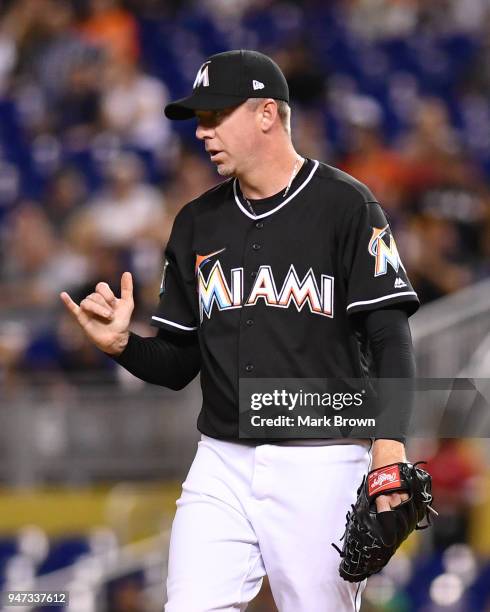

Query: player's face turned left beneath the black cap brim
196;104;256;176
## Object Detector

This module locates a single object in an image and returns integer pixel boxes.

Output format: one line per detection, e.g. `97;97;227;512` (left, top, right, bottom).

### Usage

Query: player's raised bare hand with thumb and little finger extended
60;272;134;355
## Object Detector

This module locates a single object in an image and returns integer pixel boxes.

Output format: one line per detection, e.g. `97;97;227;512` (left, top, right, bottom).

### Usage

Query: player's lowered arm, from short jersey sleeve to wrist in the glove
341;193;419;510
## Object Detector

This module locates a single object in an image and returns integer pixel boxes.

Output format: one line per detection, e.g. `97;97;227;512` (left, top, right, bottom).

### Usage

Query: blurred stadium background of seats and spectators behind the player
0;0;490;612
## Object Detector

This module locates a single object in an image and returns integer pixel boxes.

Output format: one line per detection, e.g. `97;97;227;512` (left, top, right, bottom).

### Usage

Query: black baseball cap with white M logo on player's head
165;49;289;119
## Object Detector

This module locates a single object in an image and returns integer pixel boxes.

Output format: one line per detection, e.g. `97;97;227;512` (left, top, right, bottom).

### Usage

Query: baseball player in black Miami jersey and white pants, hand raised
61;50;418;612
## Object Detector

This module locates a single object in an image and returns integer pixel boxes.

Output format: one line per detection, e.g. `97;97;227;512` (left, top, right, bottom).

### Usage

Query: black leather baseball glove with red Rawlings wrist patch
332;461;437;582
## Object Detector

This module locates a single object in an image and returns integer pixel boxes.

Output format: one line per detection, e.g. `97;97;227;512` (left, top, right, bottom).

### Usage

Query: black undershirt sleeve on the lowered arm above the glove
362;308;415;442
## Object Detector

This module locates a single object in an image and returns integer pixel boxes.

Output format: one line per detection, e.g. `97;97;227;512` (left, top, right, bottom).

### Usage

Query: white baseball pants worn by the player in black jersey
165;435;370;612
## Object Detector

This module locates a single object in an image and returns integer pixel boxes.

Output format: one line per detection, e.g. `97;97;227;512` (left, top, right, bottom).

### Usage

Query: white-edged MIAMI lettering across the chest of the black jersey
196;256;334;322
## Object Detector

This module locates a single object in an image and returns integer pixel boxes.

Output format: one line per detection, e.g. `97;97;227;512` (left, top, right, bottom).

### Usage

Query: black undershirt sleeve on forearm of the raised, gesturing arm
114;329;201;391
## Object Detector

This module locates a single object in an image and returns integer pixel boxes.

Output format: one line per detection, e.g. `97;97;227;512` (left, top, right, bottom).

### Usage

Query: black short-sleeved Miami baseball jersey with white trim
152;160;419;439
